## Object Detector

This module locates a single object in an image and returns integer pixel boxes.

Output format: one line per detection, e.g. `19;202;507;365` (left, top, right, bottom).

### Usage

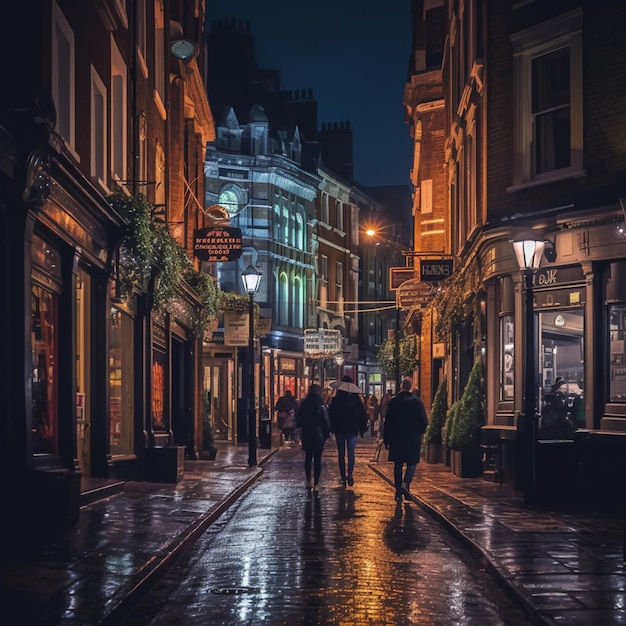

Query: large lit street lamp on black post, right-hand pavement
513;239;544;504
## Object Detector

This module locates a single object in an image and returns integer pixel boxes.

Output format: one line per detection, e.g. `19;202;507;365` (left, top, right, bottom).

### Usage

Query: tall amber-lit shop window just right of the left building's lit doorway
109;308;135;455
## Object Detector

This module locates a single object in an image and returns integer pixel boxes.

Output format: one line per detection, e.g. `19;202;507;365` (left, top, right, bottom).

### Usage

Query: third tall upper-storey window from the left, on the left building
111;36;128;181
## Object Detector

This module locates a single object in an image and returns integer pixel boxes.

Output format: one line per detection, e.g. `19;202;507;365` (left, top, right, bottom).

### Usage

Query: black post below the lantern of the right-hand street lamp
524;269;537;504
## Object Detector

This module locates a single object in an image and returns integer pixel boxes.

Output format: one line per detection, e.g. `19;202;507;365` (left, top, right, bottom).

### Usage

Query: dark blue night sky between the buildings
206;0;412;186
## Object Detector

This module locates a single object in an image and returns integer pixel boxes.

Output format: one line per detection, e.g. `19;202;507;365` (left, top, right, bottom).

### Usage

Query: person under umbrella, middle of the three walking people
328;376;368;487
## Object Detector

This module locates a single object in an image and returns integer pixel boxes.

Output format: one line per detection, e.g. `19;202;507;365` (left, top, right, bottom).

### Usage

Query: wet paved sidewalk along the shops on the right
370;451;626;626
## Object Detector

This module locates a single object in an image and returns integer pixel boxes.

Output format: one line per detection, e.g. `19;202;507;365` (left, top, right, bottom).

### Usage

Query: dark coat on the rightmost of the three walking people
384;391;428;465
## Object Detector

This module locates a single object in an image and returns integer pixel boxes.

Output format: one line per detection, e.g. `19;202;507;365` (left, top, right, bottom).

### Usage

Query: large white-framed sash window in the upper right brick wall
511;9;583;186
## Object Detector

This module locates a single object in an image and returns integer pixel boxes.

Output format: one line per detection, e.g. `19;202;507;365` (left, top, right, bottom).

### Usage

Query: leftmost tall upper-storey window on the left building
52;2;76;149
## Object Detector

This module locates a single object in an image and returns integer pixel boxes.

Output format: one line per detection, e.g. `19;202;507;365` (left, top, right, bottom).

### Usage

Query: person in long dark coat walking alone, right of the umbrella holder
384;378;428;500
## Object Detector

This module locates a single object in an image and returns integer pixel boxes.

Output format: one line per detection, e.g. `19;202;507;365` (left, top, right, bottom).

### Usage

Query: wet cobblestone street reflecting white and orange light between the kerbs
122;440;530;626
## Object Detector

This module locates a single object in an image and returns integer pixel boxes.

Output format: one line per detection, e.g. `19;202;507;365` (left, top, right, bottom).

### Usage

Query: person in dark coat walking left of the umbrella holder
296;384;330;494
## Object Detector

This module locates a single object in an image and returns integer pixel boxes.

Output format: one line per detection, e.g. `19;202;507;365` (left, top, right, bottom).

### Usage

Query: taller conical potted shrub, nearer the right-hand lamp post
448;359;485;478
